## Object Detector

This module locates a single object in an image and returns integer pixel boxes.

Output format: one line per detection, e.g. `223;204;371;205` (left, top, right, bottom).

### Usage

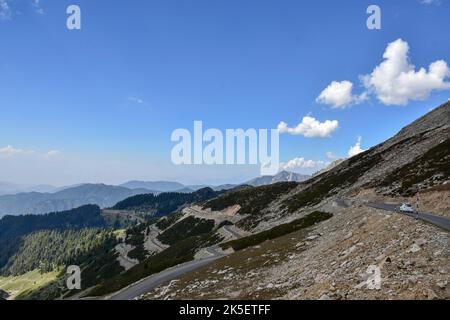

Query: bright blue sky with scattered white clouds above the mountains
0;0;450;185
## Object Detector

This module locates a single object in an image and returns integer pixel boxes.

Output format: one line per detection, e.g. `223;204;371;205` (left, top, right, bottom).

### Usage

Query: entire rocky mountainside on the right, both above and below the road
139;103;450;299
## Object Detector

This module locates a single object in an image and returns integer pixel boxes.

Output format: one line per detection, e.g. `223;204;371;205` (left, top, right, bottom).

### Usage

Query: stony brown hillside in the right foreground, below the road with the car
145;195;450;299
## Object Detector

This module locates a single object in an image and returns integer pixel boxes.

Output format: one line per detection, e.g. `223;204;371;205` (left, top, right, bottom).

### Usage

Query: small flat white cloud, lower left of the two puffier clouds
278;116;339;138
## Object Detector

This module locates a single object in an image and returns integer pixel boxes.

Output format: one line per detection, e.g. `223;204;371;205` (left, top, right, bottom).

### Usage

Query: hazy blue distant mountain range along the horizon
0;171;310;217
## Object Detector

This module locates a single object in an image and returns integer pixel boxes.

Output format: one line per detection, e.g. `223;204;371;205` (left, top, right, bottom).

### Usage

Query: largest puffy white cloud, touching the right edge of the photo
361;39;450;105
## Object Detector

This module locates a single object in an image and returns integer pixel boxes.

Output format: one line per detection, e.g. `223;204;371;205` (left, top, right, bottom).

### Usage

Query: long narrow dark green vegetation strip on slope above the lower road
221;211;333;251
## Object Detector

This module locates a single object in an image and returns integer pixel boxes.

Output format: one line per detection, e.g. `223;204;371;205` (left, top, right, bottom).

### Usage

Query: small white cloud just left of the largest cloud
316;80;367;108
